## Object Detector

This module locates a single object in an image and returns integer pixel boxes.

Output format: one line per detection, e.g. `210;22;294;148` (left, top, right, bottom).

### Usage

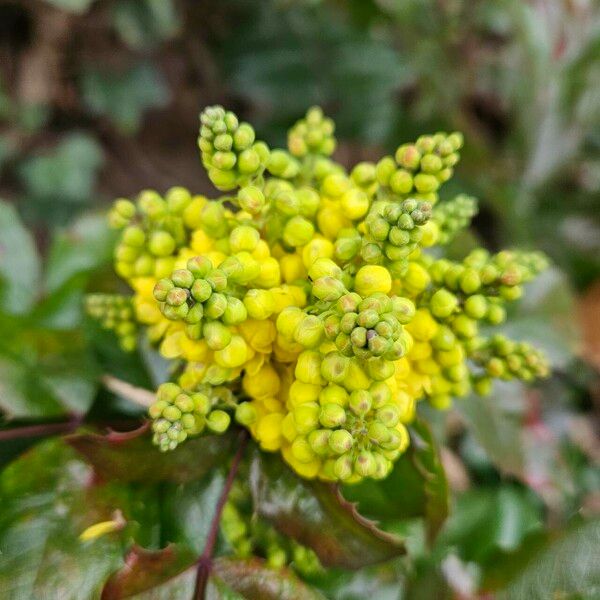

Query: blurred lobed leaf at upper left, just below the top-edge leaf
81;64;169;133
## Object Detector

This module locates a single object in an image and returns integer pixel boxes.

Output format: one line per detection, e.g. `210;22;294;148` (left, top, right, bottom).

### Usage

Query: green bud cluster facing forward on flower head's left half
154;254;250;350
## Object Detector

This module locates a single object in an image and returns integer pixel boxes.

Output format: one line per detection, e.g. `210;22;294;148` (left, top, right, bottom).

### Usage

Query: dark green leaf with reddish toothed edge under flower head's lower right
343;419;449;537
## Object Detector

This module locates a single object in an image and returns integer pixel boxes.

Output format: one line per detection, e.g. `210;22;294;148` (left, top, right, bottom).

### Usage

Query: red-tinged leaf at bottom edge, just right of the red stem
206;558;324;600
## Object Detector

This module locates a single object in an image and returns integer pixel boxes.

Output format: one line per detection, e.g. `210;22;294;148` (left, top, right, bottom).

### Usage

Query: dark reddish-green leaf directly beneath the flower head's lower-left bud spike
67;425;236;483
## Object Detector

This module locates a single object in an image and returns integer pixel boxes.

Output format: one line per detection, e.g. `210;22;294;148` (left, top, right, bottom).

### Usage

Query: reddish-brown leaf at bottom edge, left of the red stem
102;544;195;600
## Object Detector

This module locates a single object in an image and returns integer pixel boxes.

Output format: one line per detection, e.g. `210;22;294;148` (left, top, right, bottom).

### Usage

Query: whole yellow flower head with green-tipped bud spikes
88;106;548;483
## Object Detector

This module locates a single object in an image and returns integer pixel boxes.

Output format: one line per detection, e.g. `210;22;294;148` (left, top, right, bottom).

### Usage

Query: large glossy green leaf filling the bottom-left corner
0;440;126;600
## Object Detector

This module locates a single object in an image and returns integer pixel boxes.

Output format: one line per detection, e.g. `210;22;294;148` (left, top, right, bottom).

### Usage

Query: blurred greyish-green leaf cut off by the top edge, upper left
112;0;181;49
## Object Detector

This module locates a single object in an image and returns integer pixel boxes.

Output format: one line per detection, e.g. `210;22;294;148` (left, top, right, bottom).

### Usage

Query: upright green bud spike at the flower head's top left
198;106;269;190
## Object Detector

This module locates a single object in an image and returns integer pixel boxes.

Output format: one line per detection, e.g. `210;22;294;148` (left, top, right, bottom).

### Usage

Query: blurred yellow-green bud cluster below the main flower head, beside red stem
220;479;323;577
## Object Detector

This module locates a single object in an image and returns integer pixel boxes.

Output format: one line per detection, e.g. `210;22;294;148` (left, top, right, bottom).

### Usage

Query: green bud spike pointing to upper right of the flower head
376;133;463;203
